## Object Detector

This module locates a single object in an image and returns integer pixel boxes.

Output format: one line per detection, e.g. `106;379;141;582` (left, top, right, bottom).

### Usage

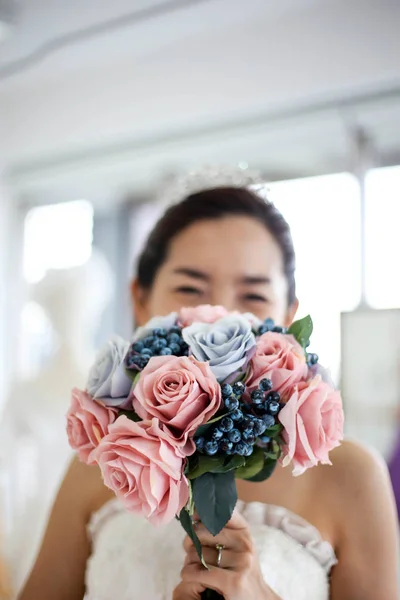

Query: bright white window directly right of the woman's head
267;173;361;380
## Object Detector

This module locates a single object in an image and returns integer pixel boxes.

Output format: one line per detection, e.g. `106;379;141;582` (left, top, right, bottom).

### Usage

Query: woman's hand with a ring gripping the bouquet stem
177;512;279;600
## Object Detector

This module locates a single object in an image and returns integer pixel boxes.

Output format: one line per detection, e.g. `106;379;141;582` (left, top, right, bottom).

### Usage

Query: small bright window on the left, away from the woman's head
24;200;93;283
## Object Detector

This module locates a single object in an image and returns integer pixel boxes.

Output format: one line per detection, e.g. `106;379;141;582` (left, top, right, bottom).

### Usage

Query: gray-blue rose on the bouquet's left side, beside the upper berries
86;336;132;408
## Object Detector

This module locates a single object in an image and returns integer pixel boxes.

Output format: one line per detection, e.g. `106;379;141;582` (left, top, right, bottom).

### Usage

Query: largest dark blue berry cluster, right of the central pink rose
195;379;281;457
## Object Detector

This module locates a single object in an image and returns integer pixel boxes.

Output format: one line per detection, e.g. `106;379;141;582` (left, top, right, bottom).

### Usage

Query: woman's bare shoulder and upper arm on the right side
320;441;398;600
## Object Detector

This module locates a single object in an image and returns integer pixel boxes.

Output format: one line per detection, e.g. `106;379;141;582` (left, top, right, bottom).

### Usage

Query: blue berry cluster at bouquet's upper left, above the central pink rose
125;326;189;371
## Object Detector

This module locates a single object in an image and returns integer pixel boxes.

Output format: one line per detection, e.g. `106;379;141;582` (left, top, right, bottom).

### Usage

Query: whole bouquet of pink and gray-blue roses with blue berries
67;306;343;596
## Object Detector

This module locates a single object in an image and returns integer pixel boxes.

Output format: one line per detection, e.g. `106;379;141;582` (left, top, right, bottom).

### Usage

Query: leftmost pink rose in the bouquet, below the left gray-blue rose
67;388;117;465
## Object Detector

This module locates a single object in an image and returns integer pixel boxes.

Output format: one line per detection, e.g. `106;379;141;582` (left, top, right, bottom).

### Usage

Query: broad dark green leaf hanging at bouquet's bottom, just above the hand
192;471;237;536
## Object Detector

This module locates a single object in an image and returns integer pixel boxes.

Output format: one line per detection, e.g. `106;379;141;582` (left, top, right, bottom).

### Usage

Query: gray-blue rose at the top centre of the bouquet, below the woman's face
182;315;256;382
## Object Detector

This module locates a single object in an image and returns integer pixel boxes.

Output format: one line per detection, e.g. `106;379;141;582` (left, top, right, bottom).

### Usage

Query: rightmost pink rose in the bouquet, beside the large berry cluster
279;375;344;475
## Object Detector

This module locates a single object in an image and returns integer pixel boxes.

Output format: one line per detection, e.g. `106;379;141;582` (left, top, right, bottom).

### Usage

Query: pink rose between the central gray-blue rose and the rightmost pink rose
246;331;308;400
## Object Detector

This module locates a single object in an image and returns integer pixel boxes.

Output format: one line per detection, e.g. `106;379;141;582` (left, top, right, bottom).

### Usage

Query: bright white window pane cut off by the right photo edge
365;167;400;309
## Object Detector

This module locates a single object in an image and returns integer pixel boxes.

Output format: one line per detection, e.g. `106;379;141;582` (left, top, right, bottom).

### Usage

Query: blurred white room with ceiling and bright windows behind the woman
0;0;400;592
